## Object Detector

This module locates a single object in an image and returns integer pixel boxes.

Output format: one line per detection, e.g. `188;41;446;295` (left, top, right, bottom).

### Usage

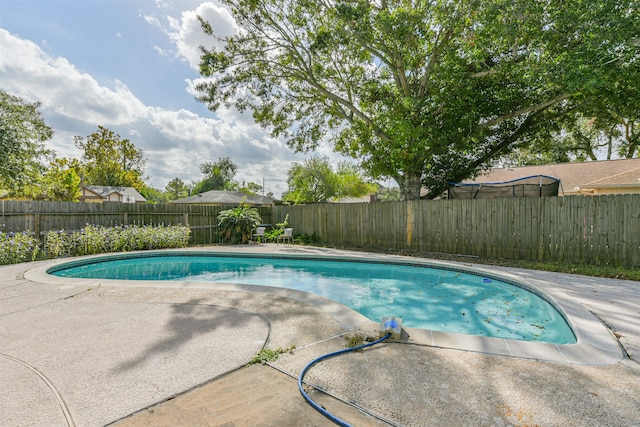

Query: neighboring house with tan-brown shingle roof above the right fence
465;159;640;196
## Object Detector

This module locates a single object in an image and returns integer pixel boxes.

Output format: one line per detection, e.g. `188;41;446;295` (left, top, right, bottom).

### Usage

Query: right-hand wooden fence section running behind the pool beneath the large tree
273;194;640;267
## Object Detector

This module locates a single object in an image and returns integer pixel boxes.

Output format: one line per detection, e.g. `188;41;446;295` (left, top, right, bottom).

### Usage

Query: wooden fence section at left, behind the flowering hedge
0;201;271;245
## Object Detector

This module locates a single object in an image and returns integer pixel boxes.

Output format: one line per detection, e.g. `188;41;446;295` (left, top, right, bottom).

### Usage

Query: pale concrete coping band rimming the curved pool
24;247;624;366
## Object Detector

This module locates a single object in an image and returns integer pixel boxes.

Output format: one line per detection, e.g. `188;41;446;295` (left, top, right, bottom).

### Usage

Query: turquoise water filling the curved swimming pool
48;254;576;344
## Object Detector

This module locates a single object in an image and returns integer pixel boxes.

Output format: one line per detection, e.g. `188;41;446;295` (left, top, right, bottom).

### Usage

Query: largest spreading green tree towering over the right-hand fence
198;0;640;199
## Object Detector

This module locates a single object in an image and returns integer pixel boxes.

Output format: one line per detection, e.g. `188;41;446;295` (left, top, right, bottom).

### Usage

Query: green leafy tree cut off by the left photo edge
0;89;53;193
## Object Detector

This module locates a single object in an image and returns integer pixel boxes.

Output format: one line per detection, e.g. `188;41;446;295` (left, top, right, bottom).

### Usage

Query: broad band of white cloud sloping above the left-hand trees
0;29;302;196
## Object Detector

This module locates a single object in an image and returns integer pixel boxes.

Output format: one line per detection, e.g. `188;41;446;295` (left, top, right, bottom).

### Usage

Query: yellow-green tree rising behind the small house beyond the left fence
74;126;146;190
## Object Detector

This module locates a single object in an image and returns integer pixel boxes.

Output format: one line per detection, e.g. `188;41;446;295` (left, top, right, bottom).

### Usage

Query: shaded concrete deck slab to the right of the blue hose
305;343;640;427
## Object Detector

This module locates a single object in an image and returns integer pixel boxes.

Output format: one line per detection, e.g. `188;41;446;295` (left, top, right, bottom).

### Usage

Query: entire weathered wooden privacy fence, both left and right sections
0;194;640;267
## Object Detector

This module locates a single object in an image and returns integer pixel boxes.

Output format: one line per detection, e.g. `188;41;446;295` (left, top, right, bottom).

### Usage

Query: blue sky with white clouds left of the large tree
0;0;342;197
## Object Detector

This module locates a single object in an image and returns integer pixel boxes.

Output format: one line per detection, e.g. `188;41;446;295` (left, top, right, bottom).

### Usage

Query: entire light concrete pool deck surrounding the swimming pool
0;244;640;427
